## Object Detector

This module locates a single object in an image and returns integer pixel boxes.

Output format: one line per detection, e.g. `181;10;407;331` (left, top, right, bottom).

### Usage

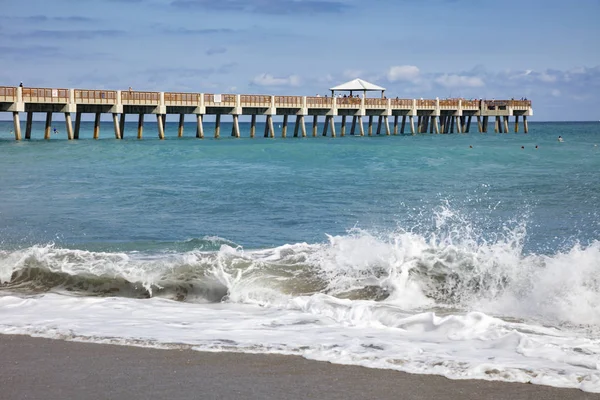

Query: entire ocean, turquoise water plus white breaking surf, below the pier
0;121;600;393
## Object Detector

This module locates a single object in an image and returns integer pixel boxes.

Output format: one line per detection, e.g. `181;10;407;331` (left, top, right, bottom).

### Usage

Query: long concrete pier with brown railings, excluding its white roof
0;86;533;140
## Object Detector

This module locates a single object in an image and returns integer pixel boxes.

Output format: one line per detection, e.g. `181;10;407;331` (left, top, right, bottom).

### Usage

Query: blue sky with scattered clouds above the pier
0;0;600;120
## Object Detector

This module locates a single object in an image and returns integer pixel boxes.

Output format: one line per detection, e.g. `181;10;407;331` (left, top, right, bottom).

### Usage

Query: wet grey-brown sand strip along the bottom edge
0;335;600;400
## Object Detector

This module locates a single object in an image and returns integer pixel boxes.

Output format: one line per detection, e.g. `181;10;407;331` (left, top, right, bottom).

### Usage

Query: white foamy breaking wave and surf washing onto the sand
0;214;600;392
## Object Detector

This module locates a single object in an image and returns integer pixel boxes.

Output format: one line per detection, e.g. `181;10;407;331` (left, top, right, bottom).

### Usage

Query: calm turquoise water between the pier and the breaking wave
0;122;600;253
